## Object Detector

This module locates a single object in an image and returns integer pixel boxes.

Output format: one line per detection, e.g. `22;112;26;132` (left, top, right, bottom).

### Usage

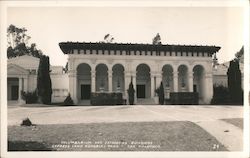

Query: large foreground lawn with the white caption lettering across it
8;121;227;151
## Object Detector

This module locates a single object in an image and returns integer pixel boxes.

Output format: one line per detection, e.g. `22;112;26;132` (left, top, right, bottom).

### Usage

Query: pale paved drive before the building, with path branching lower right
8;105;243;151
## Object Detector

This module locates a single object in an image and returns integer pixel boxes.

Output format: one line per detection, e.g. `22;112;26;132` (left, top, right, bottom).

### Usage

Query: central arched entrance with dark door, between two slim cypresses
136;64;151;98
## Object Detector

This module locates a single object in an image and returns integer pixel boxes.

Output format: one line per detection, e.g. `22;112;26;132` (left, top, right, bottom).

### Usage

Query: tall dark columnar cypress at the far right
227;60;243;104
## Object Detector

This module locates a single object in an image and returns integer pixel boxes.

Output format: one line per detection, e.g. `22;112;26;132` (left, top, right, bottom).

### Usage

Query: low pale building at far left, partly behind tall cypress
7;55;69;102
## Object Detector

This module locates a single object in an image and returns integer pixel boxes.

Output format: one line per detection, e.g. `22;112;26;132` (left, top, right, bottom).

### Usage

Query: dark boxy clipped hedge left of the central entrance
90;93;123;105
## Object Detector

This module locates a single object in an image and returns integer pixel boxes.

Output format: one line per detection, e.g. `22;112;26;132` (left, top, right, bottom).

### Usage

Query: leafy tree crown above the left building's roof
7;25;43;58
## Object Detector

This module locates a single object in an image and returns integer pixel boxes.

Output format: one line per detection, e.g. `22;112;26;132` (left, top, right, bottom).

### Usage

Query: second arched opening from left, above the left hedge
95;64;108;92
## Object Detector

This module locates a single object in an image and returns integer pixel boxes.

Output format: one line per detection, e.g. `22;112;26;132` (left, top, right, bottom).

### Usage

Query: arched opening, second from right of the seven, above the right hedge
178;64;188;92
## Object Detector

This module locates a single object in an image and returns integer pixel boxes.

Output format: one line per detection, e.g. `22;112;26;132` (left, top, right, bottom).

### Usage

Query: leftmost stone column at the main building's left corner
69;70;78;104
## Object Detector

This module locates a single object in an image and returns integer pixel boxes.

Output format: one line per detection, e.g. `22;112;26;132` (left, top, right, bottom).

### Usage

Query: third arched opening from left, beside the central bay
112;64;125;93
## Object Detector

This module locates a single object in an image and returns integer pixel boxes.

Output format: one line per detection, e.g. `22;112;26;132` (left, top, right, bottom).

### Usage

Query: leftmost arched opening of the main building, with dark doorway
77;63;91;100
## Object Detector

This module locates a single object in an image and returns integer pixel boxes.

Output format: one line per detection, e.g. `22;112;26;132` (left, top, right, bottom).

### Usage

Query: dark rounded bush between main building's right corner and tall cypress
211;85;230;105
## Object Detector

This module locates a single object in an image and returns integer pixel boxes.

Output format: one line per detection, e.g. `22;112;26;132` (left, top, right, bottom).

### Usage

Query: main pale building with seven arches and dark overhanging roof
59;42;220;104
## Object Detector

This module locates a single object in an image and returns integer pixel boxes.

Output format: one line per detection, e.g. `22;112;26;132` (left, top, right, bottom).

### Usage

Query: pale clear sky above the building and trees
7;7;244;66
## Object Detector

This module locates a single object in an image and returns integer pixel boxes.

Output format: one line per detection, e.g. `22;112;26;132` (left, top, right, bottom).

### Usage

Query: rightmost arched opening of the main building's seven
193;65;205;102
